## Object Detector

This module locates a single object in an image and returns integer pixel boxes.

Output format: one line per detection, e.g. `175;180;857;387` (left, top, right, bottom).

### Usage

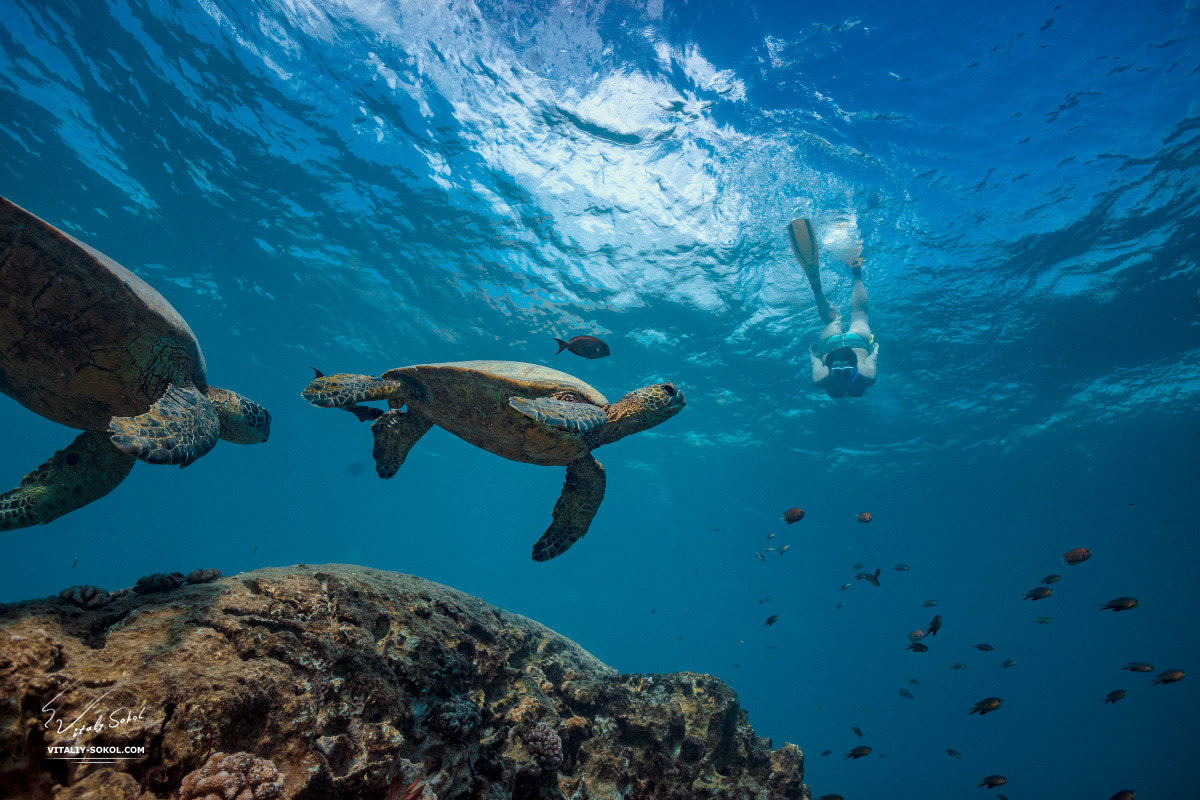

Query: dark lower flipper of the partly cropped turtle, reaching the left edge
0;431;133;530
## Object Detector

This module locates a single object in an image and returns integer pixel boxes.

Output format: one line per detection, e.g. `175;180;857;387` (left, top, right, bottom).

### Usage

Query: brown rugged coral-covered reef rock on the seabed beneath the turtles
0;565;809;800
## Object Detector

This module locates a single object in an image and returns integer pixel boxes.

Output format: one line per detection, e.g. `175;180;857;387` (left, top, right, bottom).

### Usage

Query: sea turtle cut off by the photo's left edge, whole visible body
0;198;271;530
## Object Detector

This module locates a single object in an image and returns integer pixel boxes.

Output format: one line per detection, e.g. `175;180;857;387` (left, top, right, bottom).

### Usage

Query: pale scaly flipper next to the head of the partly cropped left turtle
108;384;221;467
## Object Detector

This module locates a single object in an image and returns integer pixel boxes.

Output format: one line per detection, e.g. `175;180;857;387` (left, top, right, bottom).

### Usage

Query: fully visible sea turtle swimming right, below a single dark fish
302;361;684;561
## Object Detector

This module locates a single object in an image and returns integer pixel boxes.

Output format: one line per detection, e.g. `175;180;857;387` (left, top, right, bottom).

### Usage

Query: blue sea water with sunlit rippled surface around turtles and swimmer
0;0;1200;800
